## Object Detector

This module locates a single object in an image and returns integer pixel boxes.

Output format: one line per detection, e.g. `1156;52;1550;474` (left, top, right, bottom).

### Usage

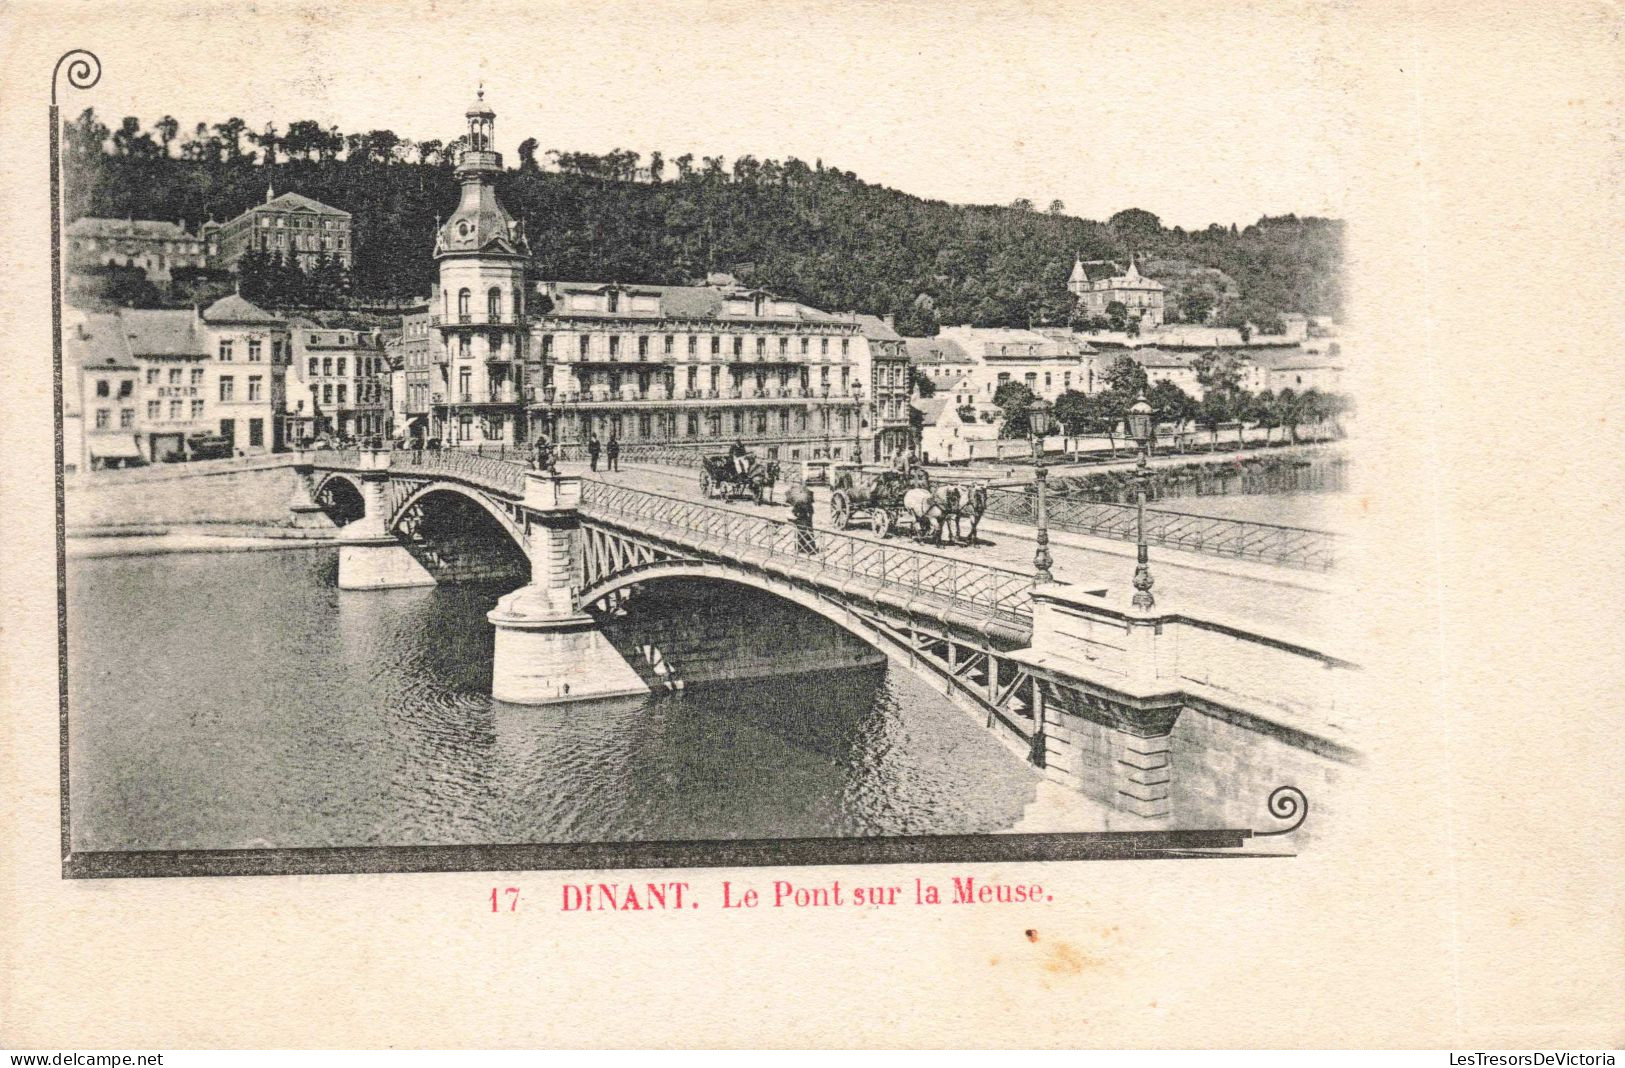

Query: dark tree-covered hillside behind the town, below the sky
65;111;1344;335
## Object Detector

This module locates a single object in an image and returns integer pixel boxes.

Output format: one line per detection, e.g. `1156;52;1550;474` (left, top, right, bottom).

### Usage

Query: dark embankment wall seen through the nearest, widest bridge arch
605;580;886;688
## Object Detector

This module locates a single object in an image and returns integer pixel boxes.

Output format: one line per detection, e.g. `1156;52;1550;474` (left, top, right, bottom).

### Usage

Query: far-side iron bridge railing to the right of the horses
985;489;1339;571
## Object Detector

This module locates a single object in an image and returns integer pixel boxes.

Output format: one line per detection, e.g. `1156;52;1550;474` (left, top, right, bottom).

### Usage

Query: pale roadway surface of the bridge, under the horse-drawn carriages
559;463;1347;655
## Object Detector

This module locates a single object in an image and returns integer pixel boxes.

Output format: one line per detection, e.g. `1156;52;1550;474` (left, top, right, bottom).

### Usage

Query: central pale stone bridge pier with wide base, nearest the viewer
486;471;648;704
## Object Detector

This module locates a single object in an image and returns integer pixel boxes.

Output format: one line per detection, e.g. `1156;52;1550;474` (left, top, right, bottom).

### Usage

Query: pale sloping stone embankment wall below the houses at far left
67;457;299;532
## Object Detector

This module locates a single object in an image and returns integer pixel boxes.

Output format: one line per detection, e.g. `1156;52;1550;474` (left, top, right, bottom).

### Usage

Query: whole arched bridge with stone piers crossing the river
294;450;1357;826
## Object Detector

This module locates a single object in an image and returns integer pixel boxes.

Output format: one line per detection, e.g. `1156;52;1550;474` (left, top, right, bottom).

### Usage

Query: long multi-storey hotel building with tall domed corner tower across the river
419;90;912;460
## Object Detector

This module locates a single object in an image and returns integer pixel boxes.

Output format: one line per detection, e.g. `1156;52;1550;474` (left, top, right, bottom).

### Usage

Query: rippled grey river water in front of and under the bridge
68;548;1038;850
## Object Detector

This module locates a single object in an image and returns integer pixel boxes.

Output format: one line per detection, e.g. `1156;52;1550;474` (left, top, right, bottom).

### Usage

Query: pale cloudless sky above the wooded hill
44;0;1355;228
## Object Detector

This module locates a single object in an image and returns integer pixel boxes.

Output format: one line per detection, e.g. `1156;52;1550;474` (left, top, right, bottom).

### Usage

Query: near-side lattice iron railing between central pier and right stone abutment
582;480;1032;624
